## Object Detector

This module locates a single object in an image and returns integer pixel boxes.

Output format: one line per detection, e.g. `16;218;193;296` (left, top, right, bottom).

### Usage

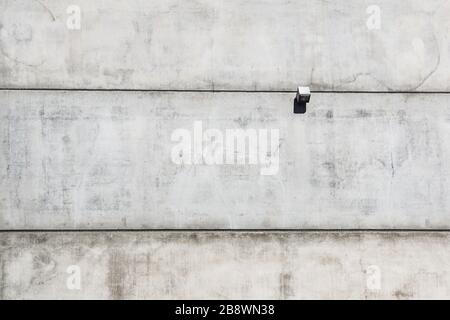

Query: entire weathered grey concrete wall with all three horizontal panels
0;0;450;299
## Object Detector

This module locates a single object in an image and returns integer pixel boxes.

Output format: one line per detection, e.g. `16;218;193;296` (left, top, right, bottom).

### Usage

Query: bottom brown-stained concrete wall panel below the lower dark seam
0;232;450;299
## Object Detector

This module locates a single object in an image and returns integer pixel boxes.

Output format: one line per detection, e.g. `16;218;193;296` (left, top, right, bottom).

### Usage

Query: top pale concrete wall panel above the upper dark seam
0;0;450;91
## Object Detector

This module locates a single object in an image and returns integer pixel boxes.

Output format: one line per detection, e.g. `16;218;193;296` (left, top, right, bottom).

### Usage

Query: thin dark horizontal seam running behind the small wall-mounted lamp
0;88;450;94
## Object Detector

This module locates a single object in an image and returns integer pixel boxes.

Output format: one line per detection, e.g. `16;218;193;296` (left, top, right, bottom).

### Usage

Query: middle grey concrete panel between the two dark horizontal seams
0;91;450;229
